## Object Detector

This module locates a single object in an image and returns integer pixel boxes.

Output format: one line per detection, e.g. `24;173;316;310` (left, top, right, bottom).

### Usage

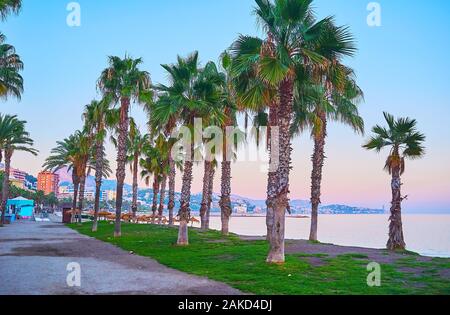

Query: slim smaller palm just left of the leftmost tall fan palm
84;99;119;232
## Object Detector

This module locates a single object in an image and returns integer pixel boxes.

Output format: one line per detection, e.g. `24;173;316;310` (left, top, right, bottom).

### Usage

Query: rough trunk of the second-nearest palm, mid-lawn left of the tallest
177;142;194;246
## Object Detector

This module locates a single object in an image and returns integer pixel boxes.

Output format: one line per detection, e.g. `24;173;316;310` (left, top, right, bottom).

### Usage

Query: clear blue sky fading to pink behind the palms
0;0;450;212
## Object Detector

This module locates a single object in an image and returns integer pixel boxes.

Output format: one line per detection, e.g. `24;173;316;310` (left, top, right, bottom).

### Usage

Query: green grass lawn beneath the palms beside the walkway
70;223;450;295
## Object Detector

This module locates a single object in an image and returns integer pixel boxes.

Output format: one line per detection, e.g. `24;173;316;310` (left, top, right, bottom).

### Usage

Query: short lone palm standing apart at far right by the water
363;113;425;250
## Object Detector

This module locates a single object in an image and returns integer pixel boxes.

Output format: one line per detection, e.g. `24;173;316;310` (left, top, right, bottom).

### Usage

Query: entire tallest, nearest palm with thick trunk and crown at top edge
230;0;354;264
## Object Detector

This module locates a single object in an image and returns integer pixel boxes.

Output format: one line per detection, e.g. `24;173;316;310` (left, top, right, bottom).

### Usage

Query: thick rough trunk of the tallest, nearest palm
267;77;294;264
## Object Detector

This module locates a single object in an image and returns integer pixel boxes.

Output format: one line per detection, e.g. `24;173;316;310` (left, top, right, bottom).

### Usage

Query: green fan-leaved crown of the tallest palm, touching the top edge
250;0;355;86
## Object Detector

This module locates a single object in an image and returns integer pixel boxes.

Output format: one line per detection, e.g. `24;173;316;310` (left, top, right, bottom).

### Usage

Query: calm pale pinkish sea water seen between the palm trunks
206;215;450;257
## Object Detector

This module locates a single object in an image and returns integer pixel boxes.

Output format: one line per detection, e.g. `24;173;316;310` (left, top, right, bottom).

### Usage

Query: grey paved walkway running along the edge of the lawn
0;221;240;295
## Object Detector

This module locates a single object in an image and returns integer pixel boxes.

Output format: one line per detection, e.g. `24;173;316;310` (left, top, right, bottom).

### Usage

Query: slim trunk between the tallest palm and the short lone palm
309;112;327;241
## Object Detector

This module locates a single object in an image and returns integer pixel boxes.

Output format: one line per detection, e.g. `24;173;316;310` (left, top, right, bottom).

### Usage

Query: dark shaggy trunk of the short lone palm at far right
387;166;406;250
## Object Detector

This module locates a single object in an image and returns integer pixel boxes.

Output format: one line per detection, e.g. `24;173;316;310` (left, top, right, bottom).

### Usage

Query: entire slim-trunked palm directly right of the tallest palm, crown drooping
292;63;364;241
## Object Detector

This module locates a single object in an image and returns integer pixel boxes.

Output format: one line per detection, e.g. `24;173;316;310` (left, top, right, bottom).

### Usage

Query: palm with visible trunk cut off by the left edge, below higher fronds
0;116;38;226
